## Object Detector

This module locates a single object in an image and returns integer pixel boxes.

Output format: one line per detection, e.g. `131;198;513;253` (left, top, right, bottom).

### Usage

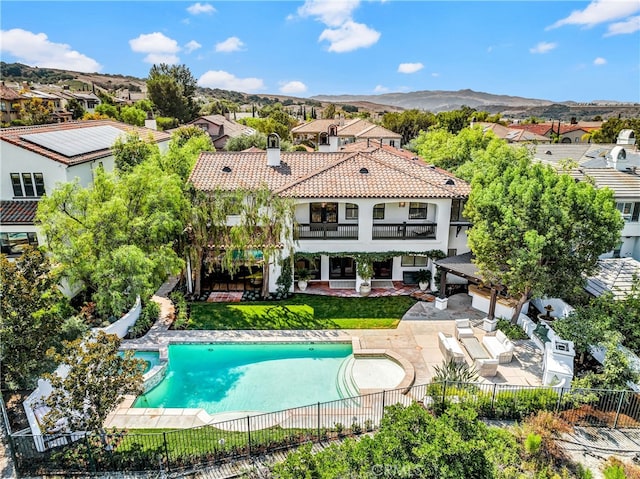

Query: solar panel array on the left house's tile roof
20;125;125;158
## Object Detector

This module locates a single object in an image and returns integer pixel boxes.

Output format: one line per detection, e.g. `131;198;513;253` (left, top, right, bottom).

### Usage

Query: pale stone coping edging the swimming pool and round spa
105;334;415;429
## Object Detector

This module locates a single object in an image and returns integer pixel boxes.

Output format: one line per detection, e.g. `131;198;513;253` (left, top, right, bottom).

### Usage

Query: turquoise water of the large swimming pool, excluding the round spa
133;343;352;414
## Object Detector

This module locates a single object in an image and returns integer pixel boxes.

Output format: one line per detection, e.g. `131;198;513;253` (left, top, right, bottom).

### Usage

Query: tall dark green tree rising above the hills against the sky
147;63;199;123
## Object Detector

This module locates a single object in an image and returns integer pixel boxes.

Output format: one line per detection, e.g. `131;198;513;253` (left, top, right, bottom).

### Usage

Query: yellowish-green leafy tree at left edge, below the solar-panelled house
0;248;70;389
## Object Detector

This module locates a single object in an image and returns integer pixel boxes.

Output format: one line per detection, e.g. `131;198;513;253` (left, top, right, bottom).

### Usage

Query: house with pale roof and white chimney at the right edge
533;134;640;260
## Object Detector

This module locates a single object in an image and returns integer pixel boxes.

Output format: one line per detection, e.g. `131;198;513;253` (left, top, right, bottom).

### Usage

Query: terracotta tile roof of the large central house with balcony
190;147;470;198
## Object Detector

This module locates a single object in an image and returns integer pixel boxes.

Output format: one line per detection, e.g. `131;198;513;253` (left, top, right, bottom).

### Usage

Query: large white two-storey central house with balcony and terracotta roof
190;135;470;291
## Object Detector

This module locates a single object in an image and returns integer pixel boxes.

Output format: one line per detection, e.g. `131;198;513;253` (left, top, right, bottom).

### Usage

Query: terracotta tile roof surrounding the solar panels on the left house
0;120;171;166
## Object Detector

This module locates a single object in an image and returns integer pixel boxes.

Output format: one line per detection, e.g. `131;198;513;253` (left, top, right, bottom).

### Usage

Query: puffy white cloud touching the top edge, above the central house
296;0;380;53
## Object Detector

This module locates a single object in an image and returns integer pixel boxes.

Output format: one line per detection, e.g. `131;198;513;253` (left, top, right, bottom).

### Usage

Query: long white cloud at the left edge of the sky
0;28;102;72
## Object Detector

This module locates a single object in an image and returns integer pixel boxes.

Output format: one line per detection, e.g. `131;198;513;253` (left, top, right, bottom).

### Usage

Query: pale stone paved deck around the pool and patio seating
106;294;542;428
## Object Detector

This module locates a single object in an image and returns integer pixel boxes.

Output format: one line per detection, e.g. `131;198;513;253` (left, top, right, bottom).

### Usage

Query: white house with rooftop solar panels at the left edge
0;120;170;255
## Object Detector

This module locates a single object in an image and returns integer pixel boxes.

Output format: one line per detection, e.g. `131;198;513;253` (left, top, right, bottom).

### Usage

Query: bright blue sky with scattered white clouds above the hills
0;0;640;102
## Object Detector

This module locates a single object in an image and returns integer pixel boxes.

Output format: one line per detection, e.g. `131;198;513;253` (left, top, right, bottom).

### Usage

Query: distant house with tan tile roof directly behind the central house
291;118;402;148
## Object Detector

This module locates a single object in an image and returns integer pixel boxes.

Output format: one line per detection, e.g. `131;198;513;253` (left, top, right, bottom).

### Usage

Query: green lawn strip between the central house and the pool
189;294;416;330
